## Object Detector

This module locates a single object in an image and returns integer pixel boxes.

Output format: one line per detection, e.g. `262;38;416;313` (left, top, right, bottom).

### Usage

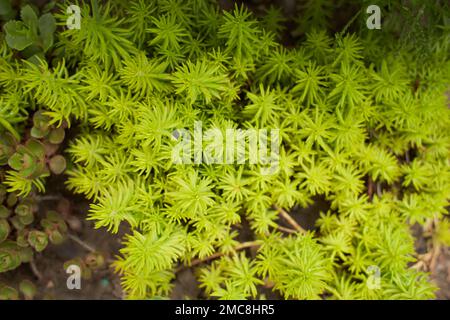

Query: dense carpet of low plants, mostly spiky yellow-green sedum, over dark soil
0;0;450;299
